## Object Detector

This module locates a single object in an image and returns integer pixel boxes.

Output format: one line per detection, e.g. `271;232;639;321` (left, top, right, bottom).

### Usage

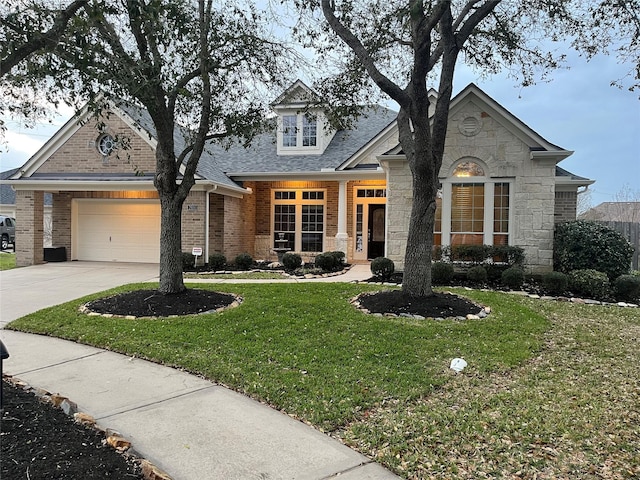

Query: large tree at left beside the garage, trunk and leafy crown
4;0;286;294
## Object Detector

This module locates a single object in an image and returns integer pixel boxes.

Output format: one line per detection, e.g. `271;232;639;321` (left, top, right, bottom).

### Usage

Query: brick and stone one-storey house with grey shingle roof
8;81;593;271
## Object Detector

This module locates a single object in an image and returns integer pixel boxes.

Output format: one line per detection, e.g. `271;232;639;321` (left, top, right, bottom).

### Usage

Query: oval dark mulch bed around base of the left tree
87;288;236;317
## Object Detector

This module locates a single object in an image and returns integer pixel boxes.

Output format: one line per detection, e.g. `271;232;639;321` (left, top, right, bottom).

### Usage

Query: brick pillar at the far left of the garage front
16;190;44;267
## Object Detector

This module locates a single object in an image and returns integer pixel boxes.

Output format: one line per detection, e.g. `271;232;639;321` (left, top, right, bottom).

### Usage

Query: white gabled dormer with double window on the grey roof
272;80;336;155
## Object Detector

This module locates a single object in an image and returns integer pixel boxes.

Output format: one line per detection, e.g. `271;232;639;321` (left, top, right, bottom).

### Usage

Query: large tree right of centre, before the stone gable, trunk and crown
296;0;636;296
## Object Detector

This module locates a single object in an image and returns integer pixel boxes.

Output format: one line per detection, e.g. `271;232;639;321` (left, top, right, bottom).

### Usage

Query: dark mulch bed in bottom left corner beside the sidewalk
0;381;143;480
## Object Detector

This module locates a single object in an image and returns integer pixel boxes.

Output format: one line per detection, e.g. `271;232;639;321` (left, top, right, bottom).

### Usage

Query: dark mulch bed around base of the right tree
358;290;482;318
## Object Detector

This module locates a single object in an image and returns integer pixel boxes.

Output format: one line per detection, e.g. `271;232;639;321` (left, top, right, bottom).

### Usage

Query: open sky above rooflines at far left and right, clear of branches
0;50;640;206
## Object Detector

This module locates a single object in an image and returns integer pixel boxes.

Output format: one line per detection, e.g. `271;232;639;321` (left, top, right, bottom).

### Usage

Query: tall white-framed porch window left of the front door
273;190;325;252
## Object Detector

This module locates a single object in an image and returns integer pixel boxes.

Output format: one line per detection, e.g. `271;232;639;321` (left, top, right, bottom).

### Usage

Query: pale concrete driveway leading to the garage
0;262;159;328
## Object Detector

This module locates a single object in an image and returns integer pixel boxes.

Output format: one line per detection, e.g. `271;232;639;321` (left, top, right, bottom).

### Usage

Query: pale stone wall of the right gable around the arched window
383;98;555;272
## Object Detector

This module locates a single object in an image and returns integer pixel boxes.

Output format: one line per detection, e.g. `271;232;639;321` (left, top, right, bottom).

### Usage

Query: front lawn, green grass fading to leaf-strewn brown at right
10;283;640;479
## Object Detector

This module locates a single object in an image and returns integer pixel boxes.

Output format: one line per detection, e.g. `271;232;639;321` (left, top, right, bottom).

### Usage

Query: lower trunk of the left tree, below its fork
158;192;186;295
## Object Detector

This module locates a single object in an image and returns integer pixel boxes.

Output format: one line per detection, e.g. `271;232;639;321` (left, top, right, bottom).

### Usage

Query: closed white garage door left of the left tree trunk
74;200;160;263
